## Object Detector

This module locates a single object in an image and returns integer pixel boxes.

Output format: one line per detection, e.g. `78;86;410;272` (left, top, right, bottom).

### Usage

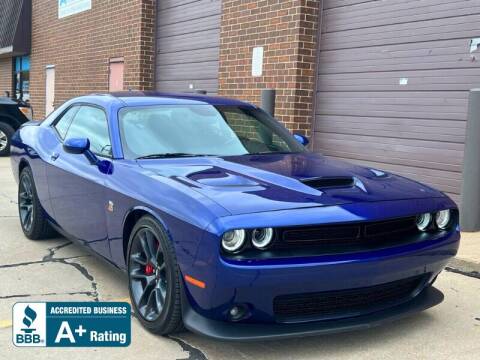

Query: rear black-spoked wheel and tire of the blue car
18;166;55;240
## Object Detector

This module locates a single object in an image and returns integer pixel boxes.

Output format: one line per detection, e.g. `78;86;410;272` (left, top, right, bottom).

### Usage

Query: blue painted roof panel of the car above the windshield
106;91;253;106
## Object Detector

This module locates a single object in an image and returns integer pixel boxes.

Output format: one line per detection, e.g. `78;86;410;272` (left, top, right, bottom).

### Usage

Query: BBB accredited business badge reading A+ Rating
13;302;131;347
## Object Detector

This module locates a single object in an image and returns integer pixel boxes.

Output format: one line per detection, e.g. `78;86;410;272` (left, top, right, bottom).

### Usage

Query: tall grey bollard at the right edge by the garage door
460;89;480;231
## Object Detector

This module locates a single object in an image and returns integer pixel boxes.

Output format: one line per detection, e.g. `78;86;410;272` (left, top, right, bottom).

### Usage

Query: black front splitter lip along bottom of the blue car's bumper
183;287;443;341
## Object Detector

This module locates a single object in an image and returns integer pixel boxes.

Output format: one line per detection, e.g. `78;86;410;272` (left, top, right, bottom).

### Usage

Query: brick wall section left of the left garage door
30;0;155;118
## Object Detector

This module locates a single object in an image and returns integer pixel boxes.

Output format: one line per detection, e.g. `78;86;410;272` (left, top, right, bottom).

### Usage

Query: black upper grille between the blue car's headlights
278;217;418;254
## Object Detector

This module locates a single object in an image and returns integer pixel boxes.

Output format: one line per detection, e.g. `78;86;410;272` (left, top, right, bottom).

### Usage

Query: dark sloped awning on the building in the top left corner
0;0;32;57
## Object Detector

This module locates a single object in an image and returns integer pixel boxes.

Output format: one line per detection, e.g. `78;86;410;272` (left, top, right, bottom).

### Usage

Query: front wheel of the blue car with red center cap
127;215;183;335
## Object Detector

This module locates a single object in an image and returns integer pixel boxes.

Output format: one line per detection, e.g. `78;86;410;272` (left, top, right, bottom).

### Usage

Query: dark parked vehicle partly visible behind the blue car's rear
0;96;32;156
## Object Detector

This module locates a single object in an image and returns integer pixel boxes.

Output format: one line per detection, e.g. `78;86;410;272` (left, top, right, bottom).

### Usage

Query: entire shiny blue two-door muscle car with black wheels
11;92;460;340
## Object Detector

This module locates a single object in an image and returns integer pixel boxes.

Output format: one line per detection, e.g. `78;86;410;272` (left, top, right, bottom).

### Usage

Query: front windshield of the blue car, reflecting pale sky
119;105;305;159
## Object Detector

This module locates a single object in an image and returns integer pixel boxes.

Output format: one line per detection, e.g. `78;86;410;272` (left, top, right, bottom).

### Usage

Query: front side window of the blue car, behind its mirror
67;106;112;156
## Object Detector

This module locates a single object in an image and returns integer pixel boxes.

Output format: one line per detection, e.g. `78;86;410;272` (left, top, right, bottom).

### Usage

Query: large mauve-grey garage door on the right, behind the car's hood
314;0;480;201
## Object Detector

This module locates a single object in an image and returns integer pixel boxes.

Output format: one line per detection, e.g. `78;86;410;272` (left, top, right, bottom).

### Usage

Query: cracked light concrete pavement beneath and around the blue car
0;158;480;360
